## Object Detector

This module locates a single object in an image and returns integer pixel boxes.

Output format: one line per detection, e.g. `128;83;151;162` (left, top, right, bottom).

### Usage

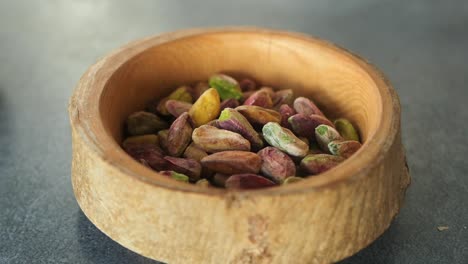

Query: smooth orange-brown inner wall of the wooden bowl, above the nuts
99;32;382;191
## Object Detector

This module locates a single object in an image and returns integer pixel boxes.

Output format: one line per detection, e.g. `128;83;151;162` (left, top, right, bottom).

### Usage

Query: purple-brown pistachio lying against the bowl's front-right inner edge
301;154;345;174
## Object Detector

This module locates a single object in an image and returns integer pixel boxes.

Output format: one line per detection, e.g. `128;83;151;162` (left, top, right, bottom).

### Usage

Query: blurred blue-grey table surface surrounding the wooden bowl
0;0;468;264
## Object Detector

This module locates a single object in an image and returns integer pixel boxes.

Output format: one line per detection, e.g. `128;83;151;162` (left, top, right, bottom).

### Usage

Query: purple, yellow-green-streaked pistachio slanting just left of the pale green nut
217;108;263;149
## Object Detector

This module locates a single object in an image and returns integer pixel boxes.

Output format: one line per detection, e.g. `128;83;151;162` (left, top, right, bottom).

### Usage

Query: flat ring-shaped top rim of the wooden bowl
68;27;400;196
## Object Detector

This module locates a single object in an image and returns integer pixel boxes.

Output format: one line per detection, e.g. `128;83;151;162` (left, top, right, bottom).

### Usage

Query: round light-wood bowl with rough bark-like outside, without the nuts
69;28;410;264
